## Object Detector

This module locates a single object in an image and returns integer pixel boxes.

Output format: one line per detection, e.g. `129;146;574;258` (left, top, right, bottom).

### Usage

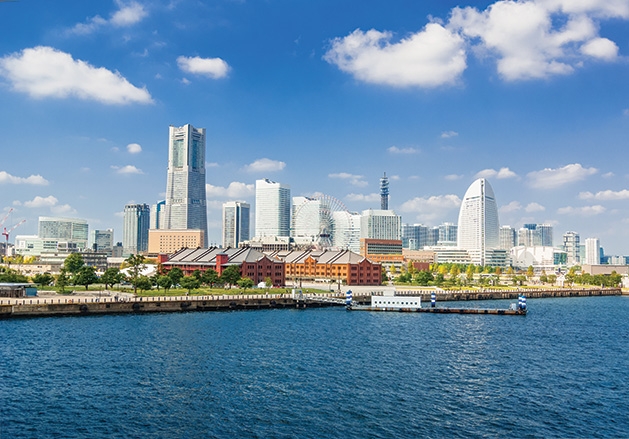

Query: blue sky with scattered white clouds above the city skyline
0;0;629;255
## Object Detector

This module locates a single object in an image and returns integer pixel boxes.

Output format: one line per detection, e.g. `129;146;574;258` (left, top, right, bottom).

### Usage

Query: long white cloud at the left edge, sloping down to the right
0;46;153;105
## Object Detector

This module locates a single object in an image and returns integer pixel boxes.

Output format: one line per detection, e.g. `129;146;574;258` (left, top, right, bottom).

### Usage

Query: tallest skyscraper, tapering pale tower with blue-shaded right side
159;124;207;246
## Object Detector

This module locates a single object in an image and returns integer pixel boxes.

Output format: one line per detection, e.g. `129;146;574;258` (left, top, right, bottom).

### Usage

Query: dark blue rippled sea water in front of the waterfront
0;297;629;439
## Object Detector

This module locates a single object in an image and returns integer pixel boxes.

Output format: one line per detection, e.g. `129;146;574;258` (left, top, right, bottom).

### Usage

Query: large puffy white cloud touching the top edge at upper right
447;0;627;81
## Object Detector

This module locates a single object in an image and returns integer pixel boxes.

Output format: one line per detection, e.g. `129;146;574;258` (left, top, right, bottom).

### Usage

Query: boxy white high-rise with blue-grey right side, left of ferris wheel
256;178;290;238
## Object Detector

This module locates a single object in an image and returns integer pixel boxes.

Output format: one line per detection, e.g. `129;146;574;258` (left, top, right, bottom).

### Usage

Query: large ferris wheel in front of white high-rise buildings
293;194;350;249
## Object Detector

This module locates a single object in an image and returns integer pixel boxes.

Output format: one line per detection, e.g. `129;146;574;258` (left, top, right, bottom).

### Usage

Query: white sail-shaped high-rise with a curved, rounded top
457;178;500;265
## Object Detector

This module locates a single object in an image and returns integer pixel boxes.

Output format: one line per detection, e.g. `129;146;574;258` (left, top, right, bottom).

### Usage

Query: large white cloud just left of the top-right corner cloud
324;23;466;87
